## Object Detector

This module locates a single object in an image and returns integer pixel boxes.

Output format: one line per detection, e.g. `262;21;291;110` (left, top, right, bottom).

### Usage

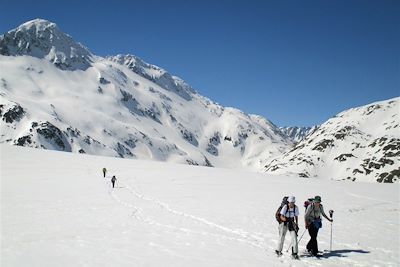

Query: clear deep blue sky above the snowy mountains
0;0;400;126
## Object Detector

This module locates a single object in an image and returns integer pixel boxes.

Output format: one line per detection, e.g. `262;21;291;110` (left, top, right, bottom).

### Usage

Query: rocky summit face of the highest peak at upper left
0;19;93;70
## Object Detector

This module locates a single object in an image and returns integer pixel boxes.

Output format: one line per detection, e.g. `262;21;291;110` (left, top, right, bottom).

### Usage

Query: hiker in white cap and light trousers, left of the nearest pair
275;196;299;259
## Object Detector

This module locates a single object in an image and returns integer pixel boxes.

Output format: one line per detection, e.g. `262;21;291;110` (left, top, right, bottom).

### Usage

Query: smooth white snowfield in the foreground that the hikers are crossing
0;144;400;267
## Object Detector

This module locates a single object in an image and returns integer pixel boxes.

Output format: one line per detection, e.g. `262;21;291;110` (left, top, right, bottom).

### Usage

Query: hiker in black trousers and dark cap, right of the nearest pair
304;196;333;257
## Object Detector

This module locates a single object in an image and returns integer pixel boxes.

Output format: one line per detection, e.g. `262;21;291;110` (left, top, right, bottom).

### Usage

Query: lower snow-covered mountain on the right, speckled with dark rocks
265;97;400;183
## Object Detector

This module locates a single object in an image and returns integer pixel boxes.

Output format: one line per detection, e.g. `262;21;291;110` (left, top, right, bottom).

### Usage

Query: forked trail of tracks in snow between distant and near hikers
109;178;265;249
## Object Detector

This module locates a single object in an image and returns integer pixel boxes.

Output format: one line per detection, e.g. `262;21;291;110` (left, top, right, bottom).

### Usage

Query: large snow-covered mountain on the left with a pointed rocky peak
0;19;292;173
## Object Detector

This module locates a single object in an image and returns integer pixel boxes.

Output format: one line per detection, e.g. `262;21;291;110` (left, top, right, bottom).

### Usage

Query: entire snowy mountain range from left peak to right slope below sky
0;19;400;182
